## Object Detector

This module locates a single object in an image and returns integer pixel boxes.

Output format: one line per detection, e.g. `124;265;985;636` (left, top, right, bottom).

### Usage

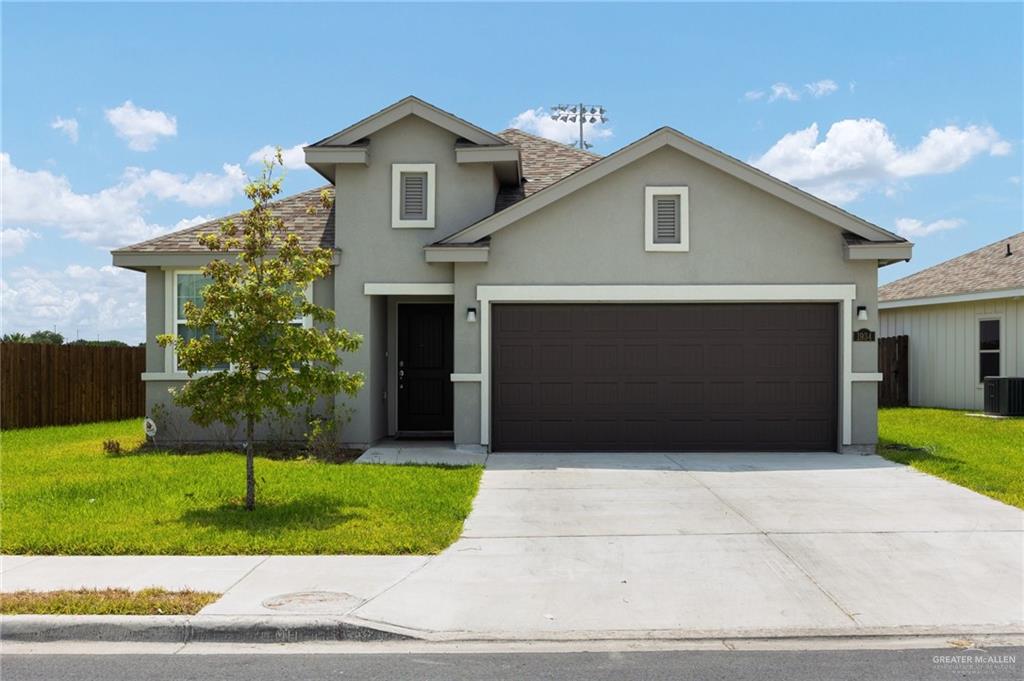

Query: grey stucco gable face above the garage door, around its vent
477;142;877;282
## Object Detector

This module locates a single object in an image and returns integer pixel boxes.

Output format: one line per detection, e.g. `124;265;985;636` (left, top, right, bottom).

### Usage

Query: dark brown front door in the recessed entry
398;303;453;433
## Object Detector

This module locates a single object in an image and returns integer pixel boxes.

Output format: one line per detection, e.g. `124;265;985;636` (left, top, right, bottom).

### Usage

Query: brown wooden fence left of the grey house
0;343;145;429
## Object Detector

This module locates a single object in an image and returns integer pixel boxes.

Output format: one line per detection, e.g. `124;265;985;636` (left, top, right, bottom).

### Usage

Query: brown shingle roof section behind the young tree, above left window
114;185;334;253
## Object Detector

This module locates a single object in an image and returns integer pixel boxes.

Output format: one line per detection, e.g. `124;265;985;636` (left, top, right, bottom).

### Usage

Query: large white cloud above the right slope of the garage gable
751;119;1009;203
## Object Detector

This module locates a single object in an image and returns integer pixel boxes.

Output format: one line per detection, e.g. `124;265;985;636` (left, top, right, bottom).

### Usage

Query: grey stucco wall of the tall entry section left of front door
335;117;497;444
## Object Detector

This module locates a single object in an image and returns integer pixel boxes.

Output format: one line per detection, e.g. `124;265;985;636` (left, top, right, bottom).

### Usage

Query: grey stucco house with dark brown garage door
114;97;911;452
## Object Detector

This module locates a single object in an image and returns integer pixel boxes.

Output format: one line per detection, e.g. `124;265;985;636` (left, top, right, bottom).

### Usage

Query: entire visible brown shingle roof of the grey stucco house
115;129;601;253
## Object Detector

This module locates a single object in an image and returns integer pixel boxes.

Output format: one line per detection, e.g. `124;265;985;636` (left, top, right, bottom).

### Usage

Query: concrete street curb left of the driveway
0;614;413;643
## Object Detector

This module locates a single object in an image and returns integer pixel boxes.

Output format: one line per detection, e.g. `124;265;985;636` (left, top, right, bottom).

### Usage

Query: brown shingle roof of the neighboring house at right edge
879;231;1024;302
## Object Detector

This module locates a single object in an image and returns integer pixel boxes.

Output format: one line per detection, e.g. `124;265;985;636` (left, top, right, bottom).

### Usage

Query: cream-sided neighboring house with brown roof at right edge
879;231;1024;410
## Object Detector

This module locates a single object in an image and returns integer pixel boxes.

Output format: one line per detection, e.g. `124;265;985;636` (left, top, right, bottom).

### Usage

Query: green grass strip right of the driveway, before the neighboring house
879;409;1024;508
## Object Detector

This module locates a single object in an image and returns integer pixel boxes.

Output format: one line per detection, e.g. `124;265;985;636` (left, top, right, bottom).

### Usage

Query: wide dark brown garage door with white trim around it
492;303;839;452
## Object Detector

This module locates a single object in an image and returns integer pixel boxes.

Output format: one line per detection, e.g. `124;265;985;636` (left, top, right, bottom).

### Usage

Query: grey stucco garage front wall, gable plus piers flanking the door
455;148;878;444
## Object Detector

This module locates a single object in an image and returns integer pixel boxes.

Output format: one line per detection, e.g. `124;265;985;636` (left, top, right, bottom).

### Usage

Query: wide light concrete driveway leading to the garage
351;454;1024;638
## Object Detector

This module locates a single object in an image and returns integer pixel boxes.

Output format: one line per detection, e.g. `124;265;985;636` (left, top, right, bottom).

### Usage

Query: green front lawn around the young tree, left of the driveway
0;420;482;555
